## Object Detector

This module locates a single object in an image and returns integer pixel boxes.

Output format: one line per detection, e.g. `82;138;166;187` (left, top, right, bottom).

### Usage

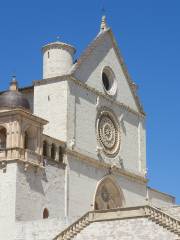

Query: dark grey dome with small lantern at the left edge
0;77;30;110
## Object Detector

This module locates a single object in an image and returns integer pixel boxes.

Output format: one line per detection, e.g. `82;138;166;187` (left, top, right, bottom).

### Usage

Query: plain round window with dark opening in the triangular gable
102;67;117;95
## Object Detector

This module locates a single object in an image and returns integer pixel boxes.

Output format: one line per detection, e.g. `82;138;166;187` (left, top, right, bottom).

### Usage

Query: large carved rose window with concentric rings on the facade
97;108;120;157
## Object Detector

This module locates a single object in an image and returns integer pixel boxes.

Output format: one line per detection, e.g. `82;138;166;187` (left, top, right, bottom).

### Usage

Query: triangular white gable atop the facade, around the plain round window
71;28;144;114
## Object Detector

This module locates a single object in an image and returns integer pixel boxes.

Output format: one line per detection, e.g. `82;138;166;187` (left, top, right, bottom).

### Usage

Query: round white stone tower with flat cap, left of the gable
42;42;76;79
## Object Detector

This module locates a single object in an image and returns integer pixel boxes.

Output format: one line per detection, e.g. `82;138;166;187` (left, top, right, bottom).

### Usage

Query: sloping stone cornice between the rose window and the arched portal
65;148;148;184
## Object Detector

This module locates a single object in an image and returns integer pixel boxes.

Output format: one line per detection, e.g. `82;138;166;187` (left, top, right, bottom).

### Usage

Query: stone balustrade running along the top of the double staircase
53;205;180;240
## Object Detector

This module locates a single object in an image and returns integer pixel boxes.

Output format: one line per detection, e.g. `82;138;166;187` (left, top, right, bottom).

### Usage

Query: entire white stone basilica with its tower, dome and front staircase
0;17;180;240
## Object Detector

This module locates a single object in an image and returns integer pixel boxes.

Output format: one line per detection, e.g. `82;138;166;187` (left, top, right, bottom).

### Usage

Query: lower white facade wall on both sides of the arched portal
68;156;146;217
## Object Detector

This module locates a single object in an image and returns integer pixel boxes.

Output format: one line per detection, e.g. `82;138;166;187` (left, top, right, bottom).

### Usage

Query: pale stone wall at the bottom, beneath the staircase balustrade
74;218;178;240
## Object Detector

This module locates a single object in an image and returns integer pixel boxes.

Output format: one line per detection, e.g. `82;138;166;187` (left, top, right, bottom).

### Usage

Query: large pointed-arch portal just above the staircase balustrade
94;176;124;210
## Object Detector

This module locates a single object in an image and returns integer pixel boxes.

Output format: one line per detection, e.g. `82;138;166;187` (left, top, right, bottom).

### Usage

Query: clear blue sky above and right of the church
0;0;180;202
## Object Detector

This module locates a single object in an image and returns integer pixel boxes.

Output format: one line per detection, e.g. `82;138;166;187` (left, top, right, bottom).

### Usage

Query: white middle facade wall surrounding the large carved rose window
68;82;146;175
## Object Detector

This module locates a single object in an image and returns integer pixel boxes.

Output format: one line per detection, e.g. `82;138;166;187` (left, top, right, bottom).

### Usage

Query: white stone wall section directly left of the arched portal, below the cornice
68;156;107;218
